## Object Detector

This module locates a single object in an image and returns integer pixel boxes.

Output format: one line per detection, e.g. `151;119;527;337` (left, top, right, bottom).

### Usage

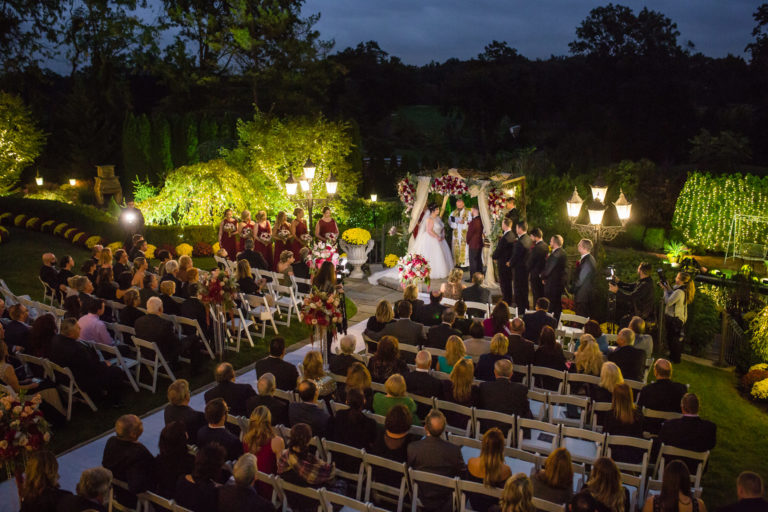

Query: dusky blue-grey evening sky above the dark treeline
304;0;760;65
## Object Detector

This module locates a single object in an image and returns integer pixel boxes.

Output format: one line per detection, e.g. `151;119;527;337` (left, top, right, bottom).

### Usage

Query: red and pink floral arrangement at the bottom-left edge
0;392;51;483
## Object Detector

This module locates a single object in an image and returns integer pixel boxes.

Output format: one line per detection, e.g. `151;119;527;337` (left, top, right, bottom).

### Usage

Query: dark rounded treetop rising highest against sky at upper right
568;4;692;58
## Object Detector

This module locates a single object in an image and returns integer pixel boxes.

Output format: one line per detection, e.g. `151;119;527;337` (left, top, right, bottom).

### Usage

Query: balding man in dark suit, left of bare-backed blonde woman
408;409;466;510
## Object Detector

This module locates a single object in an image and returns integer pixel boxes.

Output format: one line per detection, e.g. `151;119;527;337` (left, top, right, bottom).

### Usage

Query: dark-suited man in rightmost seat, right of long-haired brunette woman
658;393;717;472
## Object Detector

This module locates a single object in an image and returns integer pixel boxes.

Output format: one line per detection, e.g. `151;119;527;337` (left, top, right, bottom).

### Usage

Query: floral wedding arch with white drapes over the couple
397;169;517;287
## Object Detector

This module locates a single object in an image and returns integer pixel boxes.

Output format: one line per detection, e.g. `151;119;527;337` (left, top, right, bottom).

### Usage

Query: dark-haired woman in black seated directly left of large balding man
370;405;419;487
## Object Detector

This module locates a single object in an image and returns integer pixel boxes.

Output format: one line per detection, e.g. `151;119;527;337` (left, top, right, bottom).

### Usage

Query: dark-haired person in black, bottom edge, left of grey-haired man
173;443;222;512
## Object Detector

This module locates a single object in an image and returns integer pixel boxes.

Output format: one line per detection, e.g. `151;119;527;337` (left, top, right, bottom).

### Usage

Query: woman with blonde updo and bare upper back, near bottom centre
467;428;512;510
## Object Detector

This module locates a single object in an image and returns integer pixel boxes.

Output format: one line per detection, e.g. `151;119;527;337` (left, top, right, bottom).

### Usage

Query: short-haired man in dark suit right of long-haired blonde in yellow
480;359;533;435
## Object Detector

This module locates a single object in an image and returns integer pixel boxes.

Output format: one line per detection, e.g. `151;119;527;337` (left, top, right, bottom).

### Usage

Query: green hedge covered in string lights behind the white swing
672;172;768;252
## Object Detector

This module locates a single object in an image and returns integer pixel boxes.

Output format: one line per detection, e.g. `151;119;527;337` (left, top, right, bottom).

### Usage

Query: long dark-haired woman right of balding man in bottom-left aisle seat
155;421;195;502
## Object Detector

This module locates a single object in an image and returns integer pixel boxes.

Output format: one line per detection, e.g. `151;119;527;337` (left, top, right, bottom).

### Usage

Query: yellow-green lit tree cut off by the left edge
0;91;46;195
